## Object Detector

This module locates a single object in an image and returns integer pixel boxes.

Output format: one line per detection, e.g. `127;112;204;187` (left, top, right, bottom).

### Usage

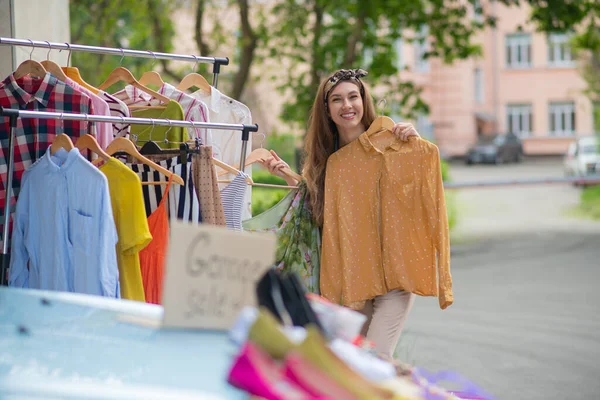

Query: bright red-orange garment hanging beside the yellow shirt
140;175;173;304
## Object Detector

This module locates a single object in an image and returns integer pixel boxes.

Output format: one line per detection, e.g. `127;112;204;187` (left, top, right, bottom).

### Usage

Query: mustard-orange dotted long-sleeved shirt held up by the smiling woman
321;133;454;310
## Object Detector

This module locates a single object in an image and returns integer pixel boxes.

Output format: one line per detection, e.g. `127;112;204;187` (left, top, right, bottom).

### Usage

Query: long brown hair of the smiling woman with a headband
302;75;377;226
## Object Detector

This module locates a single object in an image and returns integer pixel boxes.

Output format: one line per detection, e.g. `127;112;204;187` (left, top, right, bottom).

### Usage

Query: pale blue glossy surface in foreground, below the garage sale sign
0;287;247;399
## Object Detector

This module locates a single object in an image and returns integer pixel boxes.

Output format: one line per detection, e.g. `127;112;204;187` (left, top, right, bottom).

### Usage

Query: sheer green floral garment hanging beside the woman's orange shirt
242;181;321;294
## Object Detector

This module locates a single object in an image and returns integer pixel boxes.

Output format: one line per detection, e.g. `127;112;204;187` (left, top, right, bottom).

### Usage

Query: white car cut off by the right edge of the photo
564;136;600;176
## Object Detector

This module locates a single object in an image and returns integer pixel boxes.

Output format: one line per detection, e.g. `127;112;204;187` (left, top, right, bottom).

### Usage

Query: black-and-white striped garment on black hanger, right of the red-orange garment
125;154;202;222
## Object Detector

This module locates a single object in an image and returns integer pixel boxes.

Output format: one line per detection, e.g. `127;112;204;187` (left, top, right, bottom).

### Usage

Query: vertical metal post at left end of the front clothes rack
0;107;19;286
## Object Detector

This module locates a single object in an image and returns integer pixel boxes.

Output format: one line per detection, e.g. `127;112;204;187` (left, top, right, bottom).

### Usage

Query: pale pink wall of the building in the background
418;1;593;156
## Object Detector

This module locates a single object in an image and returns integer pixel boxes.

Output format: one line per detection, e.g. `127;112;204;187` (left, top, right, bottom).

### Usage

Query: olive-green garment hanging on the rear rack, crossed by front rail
130;100;188;149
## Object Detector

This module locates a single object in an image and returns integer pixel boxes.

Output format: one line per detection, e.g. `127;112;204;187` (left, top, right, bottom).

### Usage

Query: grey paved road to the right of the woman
397;160;600;400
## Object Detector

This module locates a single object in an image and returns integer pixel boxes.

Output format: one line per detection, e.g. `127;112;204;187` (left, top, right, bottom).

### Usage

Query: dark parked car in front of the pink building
466;133;523;164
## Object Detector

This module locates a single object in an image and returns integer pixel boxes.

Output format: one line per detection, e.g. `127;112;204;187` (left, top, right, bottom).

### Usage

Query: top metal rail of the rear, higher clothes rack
0;37;229;87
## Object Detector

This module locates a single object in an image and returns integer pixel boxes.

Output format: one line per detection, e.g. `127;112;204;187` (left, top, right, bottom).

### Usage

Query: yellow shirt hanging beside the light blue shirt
100;158;152;302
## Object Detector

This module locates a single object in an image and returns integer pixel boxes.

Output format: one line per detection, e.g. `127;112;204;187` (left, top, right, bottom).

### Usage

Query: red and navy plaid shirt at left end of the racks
0;73;95;241
